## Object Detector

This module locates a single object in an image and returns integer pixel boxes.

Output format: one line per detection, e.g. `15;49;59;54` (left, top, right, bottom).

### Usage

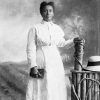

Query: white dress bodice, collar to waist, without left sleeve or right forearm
35;22;64;46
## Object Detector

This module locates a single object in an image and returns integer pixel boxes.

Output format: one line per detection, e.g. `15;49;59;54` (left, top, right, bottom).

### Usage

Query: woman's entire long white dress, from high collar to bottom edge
26;21;73;100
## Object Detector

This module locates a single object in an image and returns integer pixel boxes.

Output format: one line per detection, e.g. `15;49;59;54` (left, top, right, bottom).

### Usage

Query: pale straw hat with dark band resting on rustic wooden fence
85;56;100;71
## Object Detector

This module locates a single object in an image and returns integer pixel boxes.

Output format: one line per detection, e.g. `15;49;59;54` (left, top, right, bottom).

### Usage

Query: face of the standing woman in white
42;5;54;21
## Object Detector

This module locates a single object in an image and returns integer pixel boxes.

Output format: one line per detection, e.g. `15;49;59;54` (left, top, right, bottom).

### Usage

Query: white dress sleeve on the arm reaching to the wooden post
57;27;73;48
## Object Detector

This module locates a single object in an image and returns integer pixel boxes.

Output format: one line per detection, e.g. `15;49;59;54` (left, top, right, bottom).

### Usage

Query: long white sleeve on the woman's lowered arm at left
27;28;37;68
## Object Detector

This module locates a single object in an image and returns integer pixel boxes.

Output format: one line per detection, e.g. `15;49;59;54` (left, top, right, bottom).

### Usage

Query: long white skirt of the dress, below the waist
26;46;67;100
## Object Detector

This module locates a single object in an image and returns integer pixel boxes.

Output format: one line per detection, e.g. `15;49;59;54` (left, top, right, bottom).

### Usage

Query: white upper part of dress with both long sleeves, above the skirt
27;21;73;67
